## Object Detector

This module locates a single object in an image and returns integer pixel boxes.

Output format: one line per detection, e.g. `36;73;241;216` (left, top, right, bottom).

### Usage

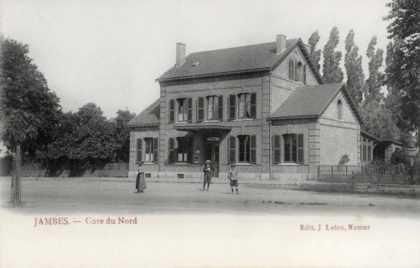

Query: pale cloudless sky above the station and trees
0;0;389;118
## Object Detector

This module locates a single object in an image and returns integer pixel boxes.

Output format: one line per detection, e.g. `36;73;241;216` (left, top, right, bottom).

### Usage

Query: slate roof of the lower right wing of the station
269;83;363;124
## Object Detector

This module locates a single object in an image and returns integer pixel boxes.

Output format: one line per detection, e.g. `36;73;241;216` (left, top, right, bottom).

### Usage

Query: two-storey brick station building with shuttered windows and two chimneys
129;35;363;180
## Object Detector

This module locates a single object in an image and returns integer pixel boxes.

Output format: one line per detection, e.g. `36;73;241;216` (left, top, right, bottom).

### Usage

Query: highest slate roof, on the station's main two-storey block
156;38;322;83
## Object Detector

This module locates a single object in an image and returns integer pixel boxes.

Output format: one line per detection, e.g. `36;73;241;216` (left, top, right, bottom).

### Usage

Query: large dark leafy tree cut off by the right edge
385;0;420;138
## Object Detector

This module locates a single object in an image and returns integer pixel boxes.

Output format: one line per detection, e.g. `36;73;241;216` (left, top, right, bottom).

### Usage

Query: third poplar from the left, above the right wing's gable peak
344;29;365;104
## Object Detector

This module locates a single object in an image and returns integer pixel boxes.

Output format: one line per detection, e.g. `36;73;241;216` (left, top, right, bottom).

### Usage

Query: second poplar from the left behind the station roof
322;27;343;83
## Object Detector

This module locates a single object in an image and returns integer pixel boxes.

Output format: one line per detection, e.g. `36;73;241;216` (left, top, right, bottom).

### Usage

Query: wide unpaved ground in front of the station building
0;178;420;217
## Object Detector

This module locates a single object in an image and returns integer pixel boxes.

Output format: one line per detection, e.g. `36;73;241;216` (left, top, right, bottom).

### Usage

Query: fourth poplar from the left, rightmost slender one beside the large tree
363;36;385;101
